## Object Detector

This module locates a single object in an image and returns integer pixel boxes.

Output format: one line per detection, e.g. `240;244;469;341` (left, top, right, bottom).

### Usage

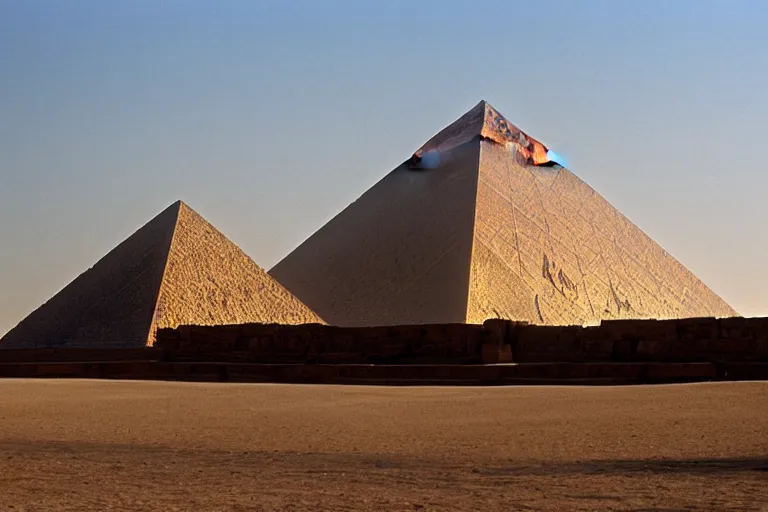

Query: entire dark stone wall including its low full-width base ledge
0;318;768;385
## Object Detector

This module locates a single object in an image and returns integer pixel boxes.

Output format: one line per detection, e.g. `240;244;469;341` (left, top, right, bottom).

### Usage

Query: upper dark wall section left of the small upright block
155;324;491;364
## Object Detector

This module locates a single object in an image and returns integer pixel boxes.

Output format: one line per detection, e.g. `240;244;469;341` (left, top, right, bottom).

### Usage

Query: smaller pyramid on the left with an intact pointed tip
0;201;321;348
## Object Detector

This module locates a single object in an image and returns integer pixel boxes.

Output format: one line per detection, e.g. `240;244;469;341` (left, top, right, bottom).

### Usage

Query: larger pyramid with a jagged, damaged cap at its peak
270;101;736;326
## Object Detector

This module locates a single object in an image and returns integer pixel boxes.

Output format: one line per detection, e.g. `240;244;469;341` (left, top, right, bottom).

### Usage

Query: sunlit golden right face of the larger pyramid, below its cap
467;141;736;325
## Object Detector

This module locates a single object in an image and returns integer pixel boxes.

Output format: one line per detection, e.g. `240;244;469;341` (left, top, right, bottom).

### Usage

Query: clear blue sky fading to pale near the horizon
0;0;768;334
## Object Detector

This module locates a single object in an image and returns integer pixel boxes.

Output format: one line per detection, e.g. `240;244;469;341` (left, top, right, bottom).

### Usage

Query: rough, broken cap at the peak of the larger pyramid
411;100;550;169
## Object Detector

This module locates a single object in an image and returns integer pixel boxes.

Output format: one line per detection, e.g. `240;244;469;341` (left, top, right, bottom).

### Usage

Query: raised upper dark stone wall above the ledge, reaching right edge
157;317;768;364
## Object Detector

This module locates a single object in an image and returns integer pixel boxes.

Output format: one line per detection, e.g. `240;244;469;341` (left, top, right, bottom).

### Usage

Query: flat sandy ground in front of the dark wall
0;380;768;512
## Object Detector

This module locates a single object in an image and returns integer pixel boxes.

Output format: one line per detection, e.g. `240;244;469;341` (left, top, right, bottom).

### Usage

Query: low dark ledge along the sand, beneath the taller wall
0;360;768;386
